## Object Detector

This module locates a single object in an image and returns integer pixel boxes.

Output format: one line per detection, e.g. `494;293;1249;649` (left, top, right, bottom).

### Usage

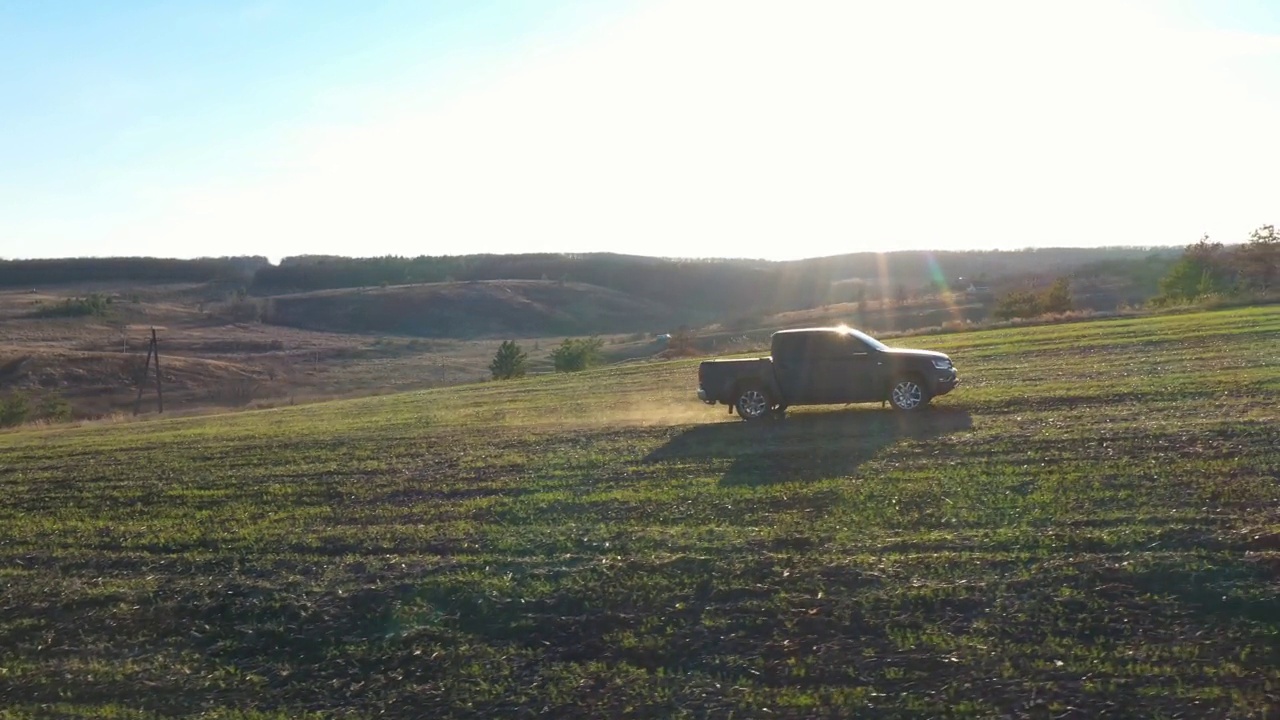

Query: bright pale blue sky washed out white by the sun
0;0;1280;260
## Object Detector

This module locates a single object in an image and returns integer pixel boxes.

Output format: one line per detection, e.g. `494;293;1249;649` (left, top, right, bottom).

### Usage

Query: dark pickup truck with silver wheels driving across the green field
698;328;960;420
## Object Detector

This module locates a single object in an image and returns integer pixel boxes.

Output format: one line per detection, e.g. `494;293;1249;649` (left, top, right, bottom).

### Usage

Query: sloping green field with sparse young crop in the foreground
0;307;1280;719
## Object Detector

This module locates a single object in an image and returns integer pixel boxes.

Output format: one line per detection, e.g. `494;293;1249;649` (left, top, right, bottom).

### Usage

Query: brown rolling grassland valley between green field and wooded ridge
0;274;987;419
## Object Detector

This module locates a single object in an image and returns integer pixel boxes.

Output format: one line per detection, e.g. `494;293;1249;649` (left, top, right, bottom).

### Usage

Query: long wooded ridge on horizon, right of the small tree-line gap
250;247;1178;315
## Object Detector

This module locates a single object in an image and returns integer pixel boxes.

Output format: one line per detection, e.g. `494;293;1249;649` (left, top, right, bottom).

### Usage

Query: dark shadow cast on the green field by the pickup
645;407;973;486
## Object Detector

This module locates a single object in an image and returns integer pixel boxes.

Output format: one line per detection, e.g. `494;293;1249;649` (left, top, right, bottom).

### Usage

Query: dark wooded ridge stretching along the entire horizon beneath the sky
0;247;1183;320
